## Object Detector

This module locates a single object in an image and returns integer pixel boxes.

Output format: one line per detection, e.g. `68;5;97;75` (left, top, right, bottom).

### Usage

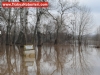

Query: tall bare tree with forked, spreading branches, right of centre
45;0;77;44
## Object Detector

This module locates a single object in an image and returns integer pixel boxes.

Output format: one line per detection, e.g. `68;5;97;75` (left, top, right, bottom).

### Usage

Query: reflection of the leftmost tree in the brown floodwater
0;46;16;75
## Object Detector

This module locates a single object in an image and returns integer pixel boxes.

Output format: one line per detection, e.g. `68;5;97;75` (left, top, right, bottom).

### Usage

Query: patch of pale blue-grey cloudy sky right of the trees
79;0;100;31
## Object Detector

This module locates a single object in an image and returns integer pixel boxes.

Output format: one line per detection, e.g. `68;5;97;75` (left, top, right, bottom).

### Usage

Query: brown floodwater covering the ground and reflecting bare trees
0;45;100;75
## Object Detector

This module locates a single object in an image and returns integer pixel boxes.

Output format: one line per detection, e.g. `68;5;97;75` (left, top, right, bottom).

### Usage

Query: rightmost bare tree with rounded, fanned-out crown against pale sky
70;6;92;45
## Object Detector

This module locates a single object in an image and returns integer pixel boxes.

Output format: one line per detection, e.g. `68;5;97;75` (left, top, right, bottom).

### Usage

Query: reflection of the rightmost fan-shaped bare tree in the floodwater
71;45;91;75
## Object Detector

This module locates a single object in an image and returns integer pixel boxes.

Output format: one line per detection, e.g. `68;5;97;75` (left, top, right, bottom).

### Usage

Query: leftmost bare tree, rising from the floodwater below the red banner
1;4;18;44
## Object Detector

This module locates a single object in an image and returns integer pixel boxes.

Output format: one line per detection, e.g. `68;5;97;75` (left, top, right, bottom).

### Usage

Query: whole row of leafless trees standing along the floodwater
0;0;91;46
